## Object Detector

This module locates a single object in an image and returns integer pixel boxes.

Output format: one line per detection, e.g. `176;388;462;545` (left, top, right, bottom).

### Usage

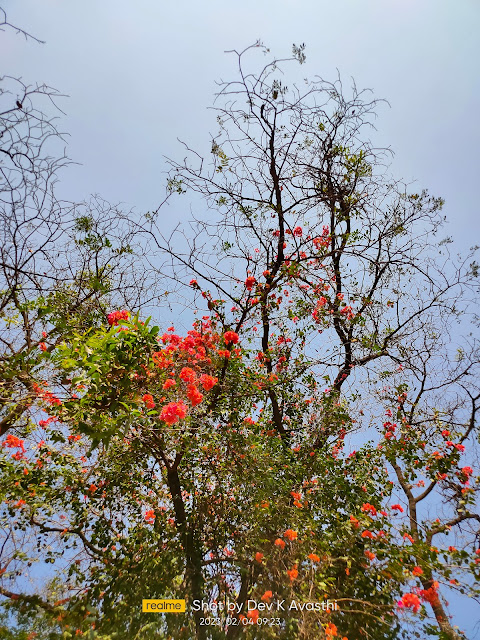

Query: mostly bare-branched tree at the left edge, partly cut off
0;9;155;435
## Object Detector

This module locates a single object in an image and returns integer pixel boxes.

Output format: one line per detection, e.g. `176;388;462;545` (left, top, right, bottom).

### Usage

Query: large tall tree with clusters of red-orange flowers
2;45;480;640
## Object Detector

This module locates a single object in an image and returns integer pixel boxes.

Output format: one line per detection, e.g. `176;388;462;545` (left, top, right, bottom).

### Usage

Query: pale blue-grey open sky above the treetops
0;0;480;638
